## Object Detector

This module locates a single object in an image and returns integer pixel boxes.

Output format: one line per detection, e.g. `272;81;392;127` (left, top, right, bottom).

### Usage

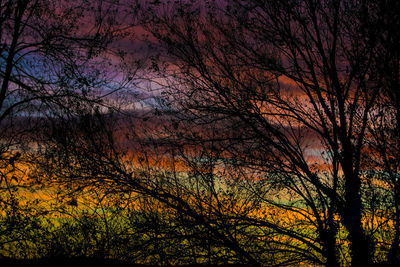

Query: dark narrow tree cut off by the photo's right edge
367;1;400;264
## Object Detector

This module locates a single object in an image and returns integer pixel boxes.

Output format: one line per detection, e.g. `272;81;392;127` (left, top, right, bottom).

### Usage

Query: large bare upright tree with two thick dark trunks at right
137;1;398;266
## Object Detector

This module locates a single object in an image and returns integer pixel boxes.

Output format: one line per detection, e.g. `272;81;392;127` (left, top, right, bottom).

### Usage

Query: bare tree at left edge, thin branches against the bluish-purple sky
0;0;128;256
